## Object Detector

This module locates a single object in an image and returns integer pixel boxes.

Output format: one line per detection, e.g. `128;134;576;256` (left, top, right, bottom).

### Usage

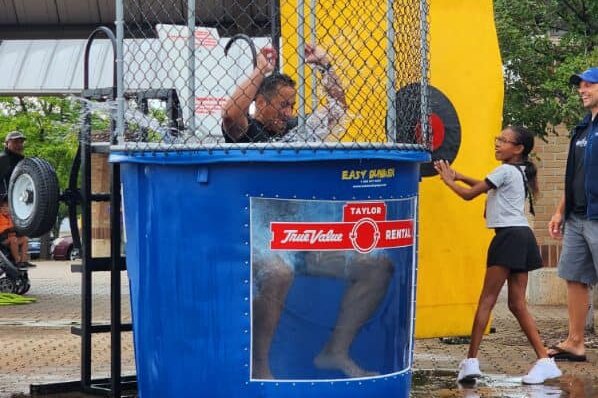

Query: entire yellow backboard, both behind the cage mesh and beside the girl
281;0;503;337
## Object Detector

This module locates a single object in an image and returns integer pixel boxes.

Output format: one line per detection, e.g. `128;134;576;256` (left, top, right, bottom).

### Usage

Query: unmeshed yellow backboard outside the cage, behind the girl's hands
416;0;503;337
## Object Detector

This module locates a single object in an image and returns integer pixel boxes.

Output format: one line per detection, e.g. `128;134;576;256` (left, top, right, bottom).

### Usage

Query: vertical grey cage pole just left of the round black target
386;0;397;142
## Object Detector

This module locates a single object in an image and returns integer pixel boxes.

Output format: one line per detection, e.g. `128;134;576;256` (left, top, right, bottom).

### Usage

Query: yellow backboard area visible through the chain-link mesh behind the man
281;0;421;142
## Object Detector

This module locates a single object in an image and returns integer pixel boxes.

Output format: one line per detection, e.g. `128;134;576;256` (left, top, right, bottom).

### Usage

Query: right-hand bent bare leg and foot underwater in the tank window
308;255;393;377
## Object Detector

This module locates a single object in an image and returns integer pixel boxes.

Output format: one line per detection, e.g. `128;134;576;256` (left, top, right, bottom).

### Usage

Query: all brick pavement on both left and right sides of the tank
0;261;598;398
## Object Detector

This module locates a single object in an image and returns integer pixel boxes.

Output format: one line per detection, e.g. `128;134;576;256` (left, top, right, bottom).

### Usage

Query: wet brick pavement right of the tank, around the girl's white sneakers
412;296;598;398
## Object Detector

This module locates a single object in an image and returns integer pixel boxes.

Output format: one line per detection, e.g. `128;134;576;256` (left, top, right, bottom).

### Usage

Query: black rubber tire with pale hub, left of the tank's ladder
8;158;60;238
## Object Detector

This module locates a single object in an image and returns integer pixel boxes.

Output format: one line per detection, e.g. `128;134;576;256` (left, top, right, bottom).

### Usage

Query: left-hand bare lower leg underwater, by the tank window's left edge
251;256;293;379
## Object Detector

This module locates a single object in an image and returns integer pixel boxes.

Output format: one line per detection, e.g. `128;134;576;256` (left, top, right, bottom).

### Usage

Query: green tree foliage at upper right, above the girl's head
494;0;598;136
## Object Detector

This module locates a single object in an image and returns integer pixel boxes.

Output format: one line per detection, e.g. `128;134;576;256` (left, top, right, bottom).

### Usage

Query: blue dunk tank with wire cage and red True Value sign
110;0;432;398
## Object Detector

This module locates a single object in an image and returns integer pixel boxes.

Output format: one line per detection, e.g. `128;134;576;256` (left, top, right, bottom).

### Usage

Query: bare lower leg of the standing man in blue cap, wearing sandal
548;281;590;355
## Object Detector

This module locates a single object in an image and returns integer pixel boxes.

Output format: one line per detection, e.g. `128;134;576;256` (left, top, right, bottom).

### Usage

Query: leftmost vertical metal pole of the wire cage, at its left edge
117;0;125;144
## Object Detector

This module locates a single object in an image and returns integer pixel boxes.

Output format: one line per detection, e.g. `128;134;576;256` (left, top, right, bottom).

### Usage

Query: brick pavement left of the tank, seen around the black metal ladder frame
0;261;135;397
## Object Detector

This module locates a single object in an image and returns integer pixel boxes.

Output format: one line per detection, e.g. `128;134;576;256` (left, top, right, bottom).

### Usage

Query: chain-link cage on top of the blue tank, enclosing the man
109;0;431;151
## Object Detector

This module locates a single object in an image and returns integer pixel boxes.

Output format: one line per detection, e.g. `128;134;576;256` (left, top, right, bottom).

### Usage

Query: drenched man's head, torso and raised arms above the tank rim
222;45;347;142
